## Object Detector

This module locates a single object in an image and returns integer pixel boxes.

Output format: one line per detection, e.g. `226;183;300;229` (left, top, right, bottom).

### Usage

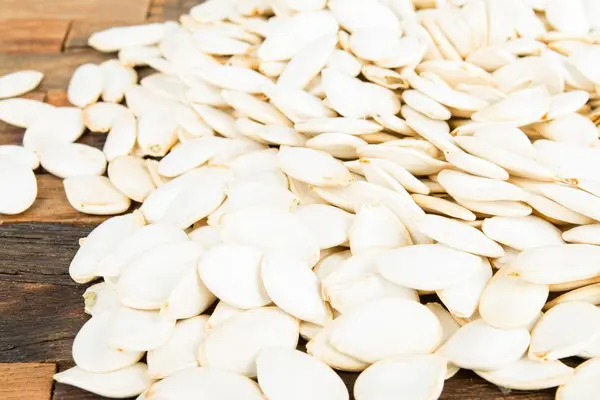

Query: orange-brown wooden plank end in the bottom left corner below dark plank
0;363;56;400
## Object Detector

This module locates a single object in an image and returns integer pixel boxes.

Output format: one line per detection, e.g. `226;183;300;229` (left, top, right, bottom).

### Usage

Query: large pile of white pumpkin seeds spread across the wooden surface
0;0;600;400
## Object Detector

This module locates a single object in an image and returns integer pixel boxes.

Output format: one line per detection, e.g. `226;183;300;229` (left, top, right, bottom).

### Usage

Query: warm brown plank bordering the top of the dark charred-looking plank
0;174;108;224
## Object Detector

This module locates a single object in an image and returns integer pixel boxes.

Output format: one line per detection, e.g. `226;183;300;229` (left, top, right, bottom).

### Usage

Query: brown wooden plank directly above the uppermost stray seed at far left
0;50;114;92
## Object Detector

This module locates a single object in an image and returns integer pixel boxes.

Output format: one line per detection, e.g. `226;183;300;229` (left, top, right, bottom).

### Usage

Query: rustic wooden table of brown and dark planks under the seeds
0;0;554;400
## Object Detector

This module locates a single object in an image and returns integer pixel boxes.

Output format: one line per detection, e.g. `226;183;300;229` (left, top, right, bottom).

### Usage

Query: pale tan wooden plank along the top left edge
0;0;150;22
